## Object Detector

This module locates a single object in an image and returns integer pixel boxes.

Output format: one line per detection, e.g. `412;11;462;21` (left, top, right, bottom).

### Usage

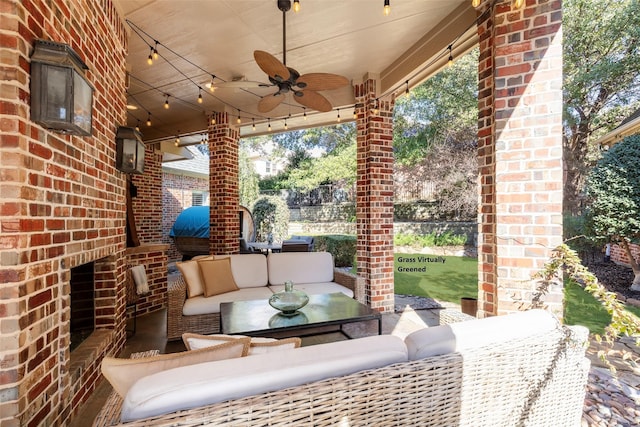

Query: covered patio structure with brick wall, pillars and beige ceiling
0;0;563;425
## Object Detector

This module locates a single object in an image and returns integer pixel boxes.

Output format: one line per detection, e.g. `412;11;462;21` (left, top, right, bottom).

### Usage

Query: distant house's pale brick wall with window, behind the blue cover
162;173;209;262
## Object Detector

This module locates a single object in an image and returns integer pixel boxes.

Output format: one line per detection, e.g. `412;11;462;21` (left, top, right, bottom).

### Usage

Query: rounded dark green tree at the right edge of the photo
587;135;640;291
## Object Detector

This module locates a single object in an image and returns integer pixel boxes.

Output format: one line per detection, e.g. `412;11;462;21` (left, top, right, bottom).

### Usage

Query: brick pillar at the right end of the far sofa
355;80;394;312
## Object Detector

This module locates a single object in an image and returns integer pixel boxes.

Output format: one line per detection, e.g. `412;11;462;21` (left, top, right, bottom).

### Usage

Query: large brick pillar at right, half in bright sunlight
478;0;563;317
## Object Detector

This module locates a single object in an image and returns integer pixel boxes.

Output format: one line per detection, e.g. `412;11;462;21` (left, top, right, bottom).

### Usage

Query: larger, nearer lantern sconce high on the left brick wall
31;40;93;136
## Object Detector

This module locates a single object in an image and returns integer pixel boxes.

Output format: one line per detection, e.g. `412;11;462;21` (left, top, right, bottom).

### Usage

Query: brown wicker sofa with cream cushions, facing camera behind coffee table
167;252;364;340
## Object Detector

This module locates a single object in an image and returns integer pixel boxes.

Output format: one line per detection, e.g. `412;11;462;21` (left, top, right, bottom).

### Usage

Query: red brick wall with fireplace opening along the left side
0;0;127;427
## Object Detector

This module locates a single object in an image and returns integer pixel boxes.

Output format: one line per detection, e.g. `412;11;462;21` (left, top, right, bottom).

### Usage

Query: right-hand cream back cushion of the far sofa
267;252;333;286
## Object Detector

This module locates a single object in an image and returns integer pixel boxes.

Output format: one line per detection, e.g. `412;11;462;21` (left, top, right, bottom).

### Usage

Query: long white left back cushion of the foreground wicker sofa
121;335;407;422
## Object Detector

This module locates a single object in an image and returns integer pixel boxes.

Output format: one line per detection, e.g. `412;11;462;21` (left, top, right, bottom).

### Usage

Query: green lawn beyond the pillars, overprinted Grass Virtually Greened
394;254;640;334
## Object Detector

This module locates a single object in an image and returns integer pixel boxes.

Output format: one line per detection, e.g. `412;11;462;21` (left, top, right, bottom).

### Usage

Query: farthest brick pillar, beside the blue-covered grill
209;113;240;254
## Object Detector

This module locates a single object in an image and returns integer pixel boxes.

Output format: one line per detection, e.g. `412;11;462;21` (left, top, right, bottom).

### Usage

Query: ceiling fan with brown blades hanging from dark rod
235;0;349;113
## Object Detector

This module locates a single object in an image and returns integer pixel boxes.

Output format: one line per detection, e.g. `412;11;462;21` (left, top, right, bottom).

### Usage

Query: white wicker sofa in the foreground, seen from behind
94;310;589;427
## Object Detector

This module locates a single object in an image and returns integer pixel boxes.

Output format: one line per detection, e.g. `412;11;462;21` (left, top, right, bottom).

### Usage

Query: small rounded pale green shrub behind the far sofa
252;196;289;242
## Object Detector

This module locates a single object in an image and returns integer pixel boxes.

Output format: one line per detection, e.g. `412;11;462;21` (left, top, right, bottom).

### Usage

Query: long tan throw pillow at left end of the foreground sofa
101;337;251;398
